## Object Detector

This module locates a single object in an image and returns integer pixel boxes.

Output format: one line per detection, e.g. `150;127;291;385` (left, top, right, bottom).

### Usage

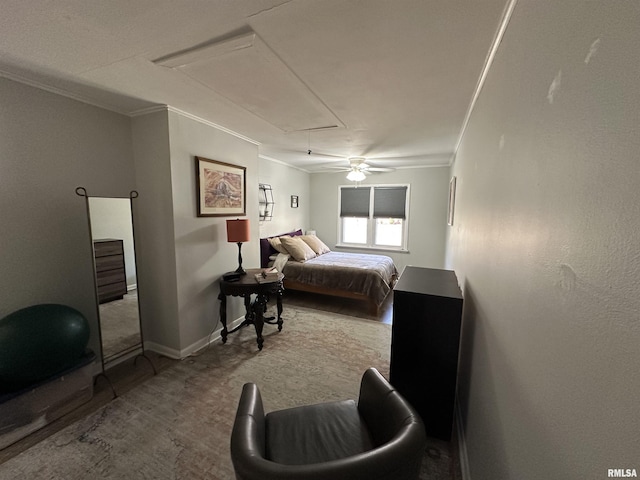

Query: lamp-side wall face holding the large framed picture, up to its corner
169;112;260;356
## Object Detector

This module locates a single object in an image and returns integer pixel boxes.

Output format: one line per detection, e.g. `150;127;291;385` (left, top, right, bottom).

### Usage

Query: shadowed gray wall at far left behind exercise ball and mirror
0;78;135;353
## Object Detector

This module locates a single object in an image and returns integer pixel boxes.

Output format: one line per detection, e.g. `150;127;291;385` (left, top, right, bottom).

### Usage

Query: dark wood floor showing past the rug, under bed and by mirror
0;290;393;464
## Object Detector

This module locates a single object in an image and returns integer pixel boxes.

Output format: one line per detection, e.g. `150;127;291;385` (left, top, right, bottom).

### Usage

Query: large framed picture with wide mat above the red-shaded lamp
196;157;247;217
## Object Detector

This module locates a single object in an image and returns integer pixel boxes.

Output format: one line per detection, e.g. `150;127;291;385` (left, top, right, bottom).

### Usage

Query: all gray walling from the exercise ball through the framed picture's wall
0;78;259;357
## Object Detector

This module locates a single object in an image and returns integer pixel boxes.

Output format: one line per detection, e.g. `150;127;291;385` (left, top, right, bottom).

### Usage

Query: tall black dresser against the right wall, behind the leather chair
390;266;462;441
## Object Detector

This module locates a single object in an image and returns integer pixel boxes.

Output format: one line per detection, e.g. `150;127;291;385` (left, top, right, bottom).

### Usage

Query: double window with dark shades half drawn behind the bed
338;185;409;250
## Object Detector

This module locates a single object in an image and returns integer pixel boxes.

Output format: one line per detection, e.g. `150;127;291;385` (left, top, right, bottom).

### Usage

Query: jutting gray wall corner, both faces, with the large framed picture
133;109;259;358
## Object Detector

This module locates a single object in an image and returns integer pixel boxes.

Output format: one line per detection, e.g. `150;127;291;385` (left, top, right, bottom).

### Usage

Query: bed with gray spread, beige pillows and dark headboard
260;230;398;314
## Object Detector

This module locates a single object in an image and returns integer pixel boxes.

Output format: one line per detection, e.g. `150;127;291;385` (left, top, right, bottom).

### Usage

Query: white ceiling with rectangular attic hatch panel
0;0;506;172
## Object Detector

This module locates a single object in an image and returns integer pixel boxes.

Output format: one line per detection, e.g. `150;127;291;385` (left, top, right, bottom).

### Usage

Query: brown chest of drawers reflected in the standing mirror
93;238;127;303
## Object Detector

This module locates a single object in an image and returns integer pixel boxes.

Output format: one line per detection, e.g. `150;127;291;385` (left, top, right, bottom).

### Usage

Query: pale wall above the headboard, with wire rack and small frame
258;158;310;238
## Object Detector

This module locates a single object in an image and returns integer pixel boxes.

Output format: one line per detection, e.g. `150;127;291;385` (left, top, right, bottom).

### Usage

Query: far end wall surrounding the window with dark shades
309;167;449;272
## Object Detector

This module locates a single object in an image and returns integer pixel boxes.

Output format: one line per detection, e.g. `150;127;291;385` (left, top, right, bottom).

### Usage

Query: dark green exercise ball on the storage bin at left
0;304;90;392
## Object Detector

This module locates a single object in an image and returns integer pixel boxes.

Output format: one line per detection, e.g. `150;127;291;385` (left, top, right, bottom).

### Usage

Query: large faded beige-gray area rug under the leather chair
0;307;458;480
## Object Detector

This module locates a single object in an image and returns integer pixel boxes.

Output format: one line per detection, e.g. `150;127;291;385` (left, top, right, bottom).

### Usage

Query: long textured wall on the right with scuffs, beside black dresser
447;0;640;480
